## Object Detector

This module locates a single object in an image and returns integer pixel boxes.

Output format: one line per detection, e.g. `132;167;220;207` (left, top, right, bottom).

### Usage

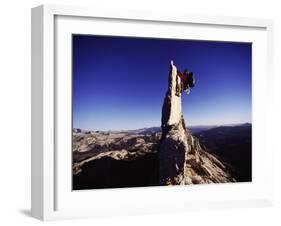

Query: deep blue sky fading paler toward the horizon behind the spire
73;35;252;130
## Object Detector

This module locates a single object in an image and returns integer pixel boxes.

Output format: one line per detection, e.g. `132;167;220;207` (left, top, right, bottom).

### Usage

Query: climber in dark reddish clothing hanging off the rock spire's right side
176;69;195;96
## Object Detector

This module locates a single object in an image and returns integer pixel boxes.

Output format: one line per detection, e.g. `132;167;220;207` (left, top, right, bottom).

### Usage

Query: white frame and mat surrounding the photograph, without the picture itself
31;5;273;220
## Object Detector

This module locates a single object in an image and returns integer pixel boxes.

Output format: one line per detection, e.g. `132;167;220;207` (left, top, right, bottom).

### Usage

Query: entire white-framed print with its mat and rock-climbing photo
32;5;273;220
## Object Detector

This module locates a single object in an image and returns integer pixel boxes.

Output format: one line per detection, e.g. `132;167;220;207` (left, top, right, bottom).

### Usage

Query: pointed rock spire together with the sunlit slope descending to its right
158;62;234;185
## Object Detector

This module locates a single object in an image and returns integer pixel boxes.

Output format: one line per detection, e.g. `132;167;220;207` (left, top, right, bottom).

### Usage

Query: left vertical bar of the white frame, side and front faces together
31;6;55;220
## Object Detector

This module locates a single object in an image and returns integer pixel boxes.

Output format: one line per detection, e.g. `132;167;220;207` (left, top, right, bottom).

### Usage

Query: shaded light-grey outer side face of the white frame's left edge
31;7;43;219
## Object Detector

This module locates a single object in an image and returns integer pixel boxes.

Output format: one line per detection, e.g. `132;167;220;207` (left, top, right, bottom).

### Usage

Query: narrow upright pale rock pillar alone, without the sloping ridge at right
159;62;190;185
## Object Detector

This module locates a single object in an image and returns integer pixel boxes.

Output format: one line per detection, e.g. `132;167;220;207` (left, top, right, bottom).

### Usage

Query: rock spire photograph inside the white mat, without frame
70;34;250;190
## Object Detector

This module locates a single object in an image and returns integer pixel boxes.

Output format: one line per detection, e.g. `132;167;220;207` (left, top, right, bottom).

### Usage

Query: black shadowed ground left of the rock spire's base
73;153;159;190
